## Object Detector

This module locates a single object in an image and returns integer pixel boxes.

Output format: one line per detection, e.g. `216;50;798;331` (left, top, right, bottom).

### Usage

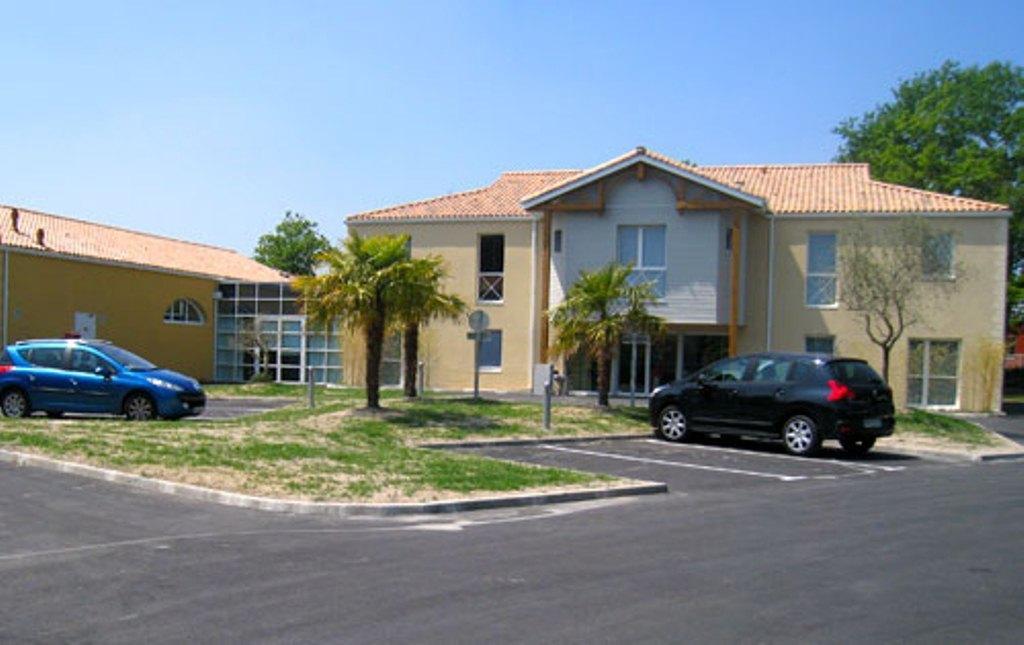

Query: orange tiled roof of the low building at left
0;206;287;282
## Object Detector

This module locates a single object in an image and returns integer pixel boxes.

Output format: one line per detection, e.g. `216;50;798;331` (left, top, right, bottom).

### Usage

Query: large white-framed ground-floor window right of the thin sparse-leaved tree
906;339;959;407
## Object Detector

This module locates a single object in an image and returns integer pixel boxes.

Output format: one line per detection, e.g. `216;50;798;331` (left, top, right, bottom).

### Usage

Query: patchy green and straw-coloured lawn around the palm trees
0;384;647;502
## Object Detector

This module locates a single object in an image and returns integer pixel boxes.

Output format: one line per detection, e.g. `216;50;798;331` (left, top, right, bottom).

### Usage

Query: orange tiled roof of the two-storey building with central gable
347;149;1010;223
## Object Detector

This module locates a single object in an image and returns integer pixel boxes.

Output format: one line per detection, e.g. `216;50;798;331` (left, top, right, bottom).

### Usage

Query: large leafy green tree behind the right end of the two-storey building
835;61;1024;321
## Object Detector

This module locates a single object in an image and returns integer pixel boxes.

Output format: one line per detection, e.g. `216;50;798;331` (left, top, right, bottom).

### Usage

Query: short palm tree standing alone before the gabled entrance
551;262;665;407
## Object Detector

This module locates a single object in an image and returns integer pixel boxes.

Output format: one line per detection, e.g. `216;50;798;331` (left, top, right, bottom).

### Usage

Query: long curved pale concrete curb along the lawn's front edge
0;449;669;517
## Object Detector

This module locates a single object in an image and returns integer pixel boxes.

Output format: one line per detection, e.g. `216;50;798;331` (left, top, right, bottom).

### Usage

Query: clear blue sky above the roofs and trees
0;1;1024;254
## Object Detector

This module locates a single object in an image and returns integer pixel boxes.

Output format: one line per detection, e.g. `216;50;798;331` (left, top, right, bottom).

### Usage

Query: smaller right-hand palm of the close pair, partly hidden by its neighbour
396;255;466;397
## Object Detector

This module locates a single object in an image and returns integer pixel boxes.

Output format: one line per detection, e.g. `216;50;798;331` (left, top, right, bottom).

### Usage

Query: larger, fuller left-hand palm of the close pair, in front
292;232;417;410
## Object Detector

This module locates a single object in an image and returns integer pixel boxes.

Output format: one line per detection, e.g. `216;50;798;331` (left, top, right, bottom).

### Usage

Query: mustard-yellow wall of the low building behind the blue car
7;252;217;380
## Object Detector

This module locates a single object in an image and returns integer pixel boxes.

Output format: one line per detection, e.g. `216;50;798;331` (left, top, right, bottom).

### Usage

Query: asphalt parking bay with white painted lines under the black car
456;437;925;492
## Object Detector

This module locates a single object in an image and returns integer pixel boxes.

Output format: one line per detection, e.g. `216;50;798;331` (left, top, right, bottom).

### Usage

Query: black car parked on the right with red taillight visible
650;352;895;456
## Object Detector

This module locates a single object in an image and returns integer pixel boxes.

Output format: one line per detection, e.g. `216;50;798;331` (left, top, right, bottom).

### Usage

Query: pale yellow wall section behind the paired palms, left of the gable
344;221;532;390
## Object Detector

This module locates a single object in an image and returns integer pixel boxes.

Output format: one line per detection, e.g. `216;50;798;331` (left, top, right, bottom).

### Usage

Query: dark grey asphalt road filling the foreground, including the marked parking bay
0;442;1024;643
